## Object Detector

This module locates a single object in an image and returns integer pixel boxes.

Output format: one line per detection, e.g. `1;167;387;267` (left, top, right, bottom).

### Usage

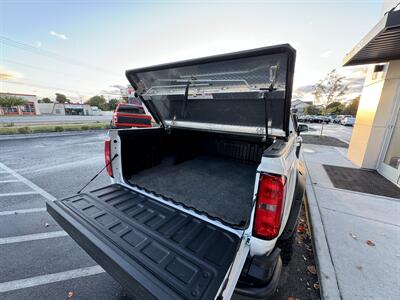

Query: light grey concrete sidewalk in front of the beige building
302;144;400;300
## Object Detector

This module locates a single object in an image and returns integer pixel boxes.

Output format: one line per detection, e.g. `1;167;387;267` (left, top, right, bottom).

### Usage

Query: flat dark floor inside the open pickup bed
129;155;257;226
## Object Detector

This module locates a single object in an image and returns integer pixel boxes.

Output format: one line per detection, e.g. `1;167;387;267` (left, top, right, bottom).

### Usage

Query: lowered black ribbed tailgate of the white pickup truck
47;184;240;299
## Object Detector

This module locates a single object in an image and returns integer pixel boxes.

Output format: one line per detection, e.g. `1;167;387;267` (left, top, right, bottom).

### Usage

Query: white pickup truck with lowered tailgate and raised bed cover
47;45;305;299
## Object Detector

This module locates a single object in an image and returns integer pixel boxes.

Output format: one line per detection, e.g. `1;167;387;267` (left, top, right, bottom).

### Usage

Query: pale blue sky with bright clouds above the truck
0;0;390;101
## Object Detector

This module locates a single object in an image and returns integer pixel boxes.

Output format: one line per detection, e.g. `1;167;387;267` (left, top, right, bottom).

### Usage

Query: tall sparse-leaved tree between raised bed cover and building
313;69;348;104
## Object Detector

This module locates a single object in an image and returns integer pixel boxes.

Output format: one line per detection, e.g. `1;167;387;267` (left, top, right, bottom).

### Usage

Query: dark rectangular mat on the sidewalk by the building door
324;165;400;199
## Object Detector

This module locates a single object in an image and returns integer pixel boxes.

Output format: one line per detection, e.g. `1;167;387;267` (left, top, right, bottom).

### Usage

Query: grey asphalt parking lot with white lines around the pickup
0;132;318;299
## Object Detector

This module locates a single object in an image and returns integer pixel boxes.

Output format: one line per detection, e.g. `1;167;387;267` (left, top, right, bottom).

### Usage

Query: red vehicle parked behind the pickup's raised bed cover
111;103;151;128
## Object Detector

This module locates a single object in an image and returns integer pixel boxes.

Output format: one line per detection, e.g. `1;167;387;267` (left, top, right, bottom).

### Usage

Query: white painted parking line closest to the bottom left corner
0;266;105;293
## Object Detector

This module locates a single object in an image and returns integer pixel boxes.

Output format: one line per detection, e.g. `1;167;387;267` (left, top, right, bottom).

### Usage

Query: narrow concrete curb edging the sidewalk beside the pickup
306;176;342;300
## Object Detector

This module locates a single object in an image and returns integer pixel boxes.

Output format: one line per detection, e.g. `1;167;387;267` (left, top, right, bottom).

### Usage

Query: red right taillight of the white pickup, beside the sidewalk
253;174;285;240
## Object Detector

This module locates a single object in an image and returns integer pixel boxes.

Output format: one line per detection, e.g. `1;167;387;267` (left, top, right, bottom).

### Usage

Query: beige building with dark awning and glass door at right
343;1;400;186
